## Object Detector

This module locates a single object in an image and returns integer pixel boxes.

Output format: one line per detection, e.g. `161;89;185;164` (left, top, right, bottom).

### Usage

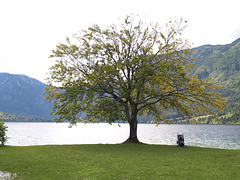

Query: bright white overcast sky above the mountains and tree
0;0;240;83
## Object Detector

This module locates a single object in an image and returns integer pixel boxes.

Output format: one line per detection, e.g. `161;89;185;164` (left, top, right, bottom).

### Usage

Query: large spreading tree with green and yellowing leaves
45;16;224;143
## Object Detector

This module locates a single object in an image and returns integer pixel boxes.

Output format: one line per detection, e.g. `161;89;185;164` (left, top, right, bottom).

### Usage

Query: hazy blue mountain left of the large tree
0;73;52;118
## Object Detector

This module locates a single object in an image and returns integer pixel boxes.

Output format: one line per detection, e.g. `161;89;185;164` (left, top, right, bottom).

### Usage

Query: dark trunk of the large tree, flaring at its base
123;113;140;143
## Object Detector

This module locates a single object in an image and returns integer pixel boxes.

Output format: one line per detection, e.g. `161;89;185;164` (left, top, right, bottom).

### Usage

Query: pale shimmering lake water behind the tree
5;123;240;149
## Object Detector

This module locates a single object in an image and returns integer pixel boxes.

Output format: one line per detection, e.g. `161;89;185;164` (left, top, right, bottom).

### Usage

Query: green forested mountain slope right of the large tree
189;38;240;123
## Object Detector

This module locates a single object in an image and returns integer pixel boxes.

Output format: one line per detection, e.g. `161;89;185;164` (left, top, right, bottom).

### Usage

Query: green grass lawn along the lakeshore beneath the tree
0;144;240;180
